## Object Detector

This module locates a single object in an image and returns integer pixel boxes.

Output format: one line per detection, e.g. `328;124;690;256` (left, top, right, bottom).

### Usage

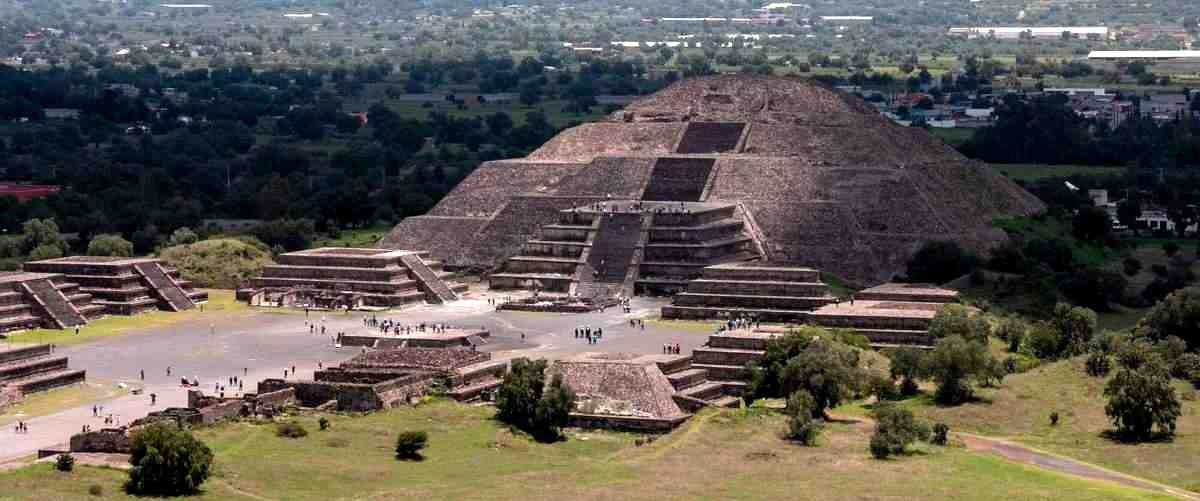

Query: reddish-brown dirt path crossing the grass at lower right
954;433;1200;501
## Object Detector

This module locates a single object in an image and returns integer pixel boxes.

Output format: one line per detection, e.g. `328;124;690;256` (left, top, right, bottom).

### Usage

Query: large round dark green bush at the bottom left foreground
125;422;212;496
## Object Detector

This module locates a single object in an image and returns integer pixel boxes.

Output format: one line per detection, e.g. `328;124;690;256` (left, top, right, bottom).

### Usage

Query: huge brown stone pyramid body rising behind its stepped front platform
380;76;1044;284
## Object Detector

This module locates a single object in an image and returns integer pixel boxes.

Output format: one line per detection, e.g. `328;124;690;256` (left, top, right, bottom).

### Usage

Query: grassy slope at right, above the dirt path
847;358;1200;491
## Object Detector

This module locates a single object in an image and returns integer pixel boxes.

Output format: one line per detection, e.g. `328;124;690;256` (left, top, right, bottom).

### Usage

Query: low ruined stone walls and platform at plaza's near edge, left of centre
258;348;508;412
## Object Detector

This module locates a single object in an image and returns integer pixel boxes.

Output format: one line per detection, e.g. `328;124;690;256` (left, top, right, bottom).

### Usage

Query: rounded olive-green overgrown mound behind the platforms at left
160;239;271;289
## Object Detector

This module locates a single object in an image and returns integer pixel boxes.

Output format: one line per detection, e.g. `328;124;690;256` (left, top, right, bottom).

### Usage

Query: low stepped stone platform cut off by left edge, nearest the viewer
0;344;88;409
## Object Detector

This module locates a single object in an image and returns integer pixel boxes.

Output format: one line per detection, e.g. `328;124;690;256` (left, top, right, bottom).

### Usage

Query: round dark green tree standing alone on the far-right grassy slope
1104;355;1181;441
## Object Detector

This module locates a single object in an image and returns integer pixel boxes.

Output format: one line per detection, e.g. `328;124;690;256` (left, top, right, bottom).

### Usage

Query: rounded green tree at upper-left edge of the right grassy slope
926;336;991;405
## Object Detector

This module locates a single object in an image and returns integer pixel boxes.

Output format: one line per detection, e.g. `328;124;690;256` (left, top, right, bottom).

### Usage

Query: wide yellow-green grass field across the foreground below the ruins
0;403;1163;501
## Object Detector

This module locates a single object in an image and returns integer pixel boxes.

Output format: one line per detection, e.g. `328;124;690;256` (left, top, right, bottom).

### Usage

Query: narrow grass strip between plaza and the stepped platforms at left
0;289;247;346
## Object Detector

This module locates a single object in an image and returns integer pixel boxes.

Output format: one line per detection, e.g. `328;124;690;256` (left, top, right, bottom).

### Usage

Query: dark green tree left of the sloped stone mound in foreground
496;358;575;441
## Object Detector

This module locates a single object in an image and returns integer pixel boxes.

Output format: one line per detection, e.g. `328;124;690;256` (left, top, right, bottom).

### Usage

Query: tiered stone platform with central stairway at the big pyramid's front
490;200;760;298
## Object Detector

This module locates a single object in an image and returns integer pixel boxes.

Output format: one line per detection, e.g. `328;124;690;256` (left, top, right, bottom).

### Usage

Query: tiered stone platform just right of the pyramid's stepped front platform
662;262;836;322
